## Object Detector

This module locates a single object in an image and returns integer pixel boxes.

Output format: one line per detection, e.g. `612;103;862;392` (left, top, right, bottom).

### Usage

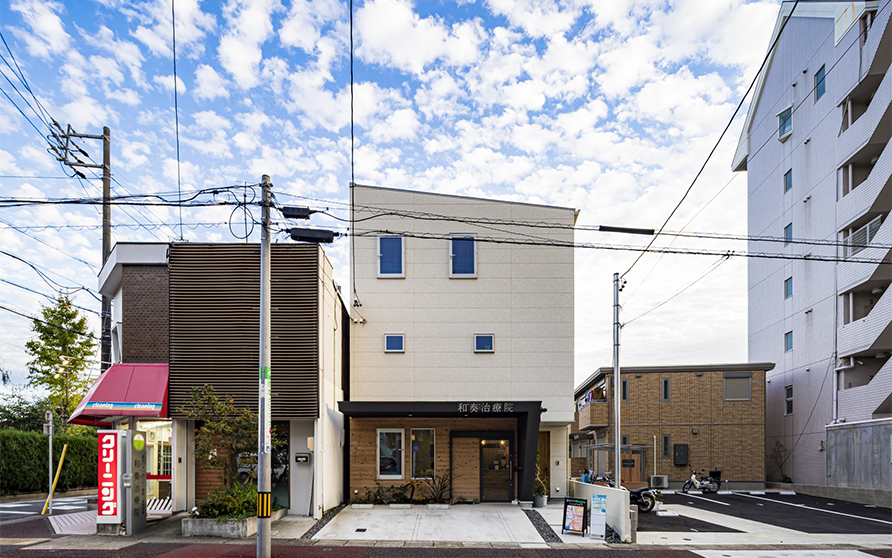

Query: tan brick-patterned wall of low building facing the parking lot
592;370;765;482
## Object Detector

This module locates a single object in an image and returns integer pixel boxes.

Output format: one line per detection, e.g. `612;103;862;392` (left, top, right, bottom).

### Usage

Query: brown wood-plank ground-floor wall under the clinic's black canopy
350;417;517;499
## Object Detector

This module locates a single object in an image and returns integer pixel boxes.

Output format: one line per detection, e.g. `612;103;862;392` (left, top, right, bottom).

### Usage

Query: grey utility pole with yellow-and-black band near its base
257;174;272;558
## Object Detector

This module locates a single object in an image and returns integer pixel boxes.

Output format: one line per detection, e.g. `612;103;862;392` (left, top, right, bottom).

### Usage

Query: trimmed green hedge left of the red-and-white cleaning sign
0;430;99;494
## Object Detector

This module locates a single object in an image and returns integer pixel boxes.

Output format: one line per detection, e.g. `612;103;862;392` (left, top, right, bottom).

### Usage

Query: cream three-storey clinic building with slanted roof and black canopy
339;185;577;501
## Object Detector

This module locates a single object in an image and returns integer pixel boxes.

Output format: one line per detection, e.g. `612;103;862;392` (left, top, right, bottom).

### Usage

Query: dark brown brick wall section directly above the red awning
121;265;170;363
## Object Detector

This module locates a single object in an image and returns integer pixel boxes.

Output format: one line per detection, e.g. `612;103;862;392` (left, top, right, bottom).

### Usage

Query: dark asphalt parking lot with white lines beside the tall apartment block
652;492;892;535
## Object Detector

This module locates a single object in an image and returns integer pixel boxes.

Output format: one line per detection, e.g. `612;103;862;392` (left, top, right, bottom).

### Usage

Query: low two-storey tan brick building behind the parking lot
570;363;774;489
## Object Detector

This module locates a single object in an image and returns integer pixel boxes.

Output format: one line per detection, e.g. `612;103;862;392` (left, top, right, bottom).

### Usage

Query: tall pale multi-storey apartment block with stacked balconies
733;0;892;489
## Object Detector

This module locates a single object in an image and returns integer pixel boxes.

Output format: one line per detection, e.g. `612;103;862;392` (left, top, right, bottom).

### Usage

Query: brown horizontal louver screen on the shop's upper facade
169;243;319;420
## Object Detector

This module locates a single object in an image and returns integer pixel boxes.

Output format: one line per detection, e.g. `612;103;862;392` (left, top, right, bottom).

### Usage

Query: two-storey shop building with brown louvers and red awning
74;242;350;518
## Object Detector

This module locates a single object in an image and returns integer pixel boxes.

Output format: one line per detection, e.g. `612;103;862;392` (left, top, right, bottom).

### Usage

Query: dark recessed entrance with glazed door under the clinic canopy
450;431;516;502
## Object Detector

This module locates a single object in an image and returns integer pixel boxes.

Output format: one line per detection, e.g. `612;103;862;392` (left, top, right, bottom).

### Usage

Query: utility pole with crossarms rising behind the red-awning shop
47;124;111;373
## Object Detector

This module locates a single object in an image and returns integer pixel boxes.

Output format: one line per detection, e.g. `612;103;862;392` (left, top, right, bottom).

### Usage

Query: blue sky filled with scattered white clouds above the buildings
0;0;780;394
